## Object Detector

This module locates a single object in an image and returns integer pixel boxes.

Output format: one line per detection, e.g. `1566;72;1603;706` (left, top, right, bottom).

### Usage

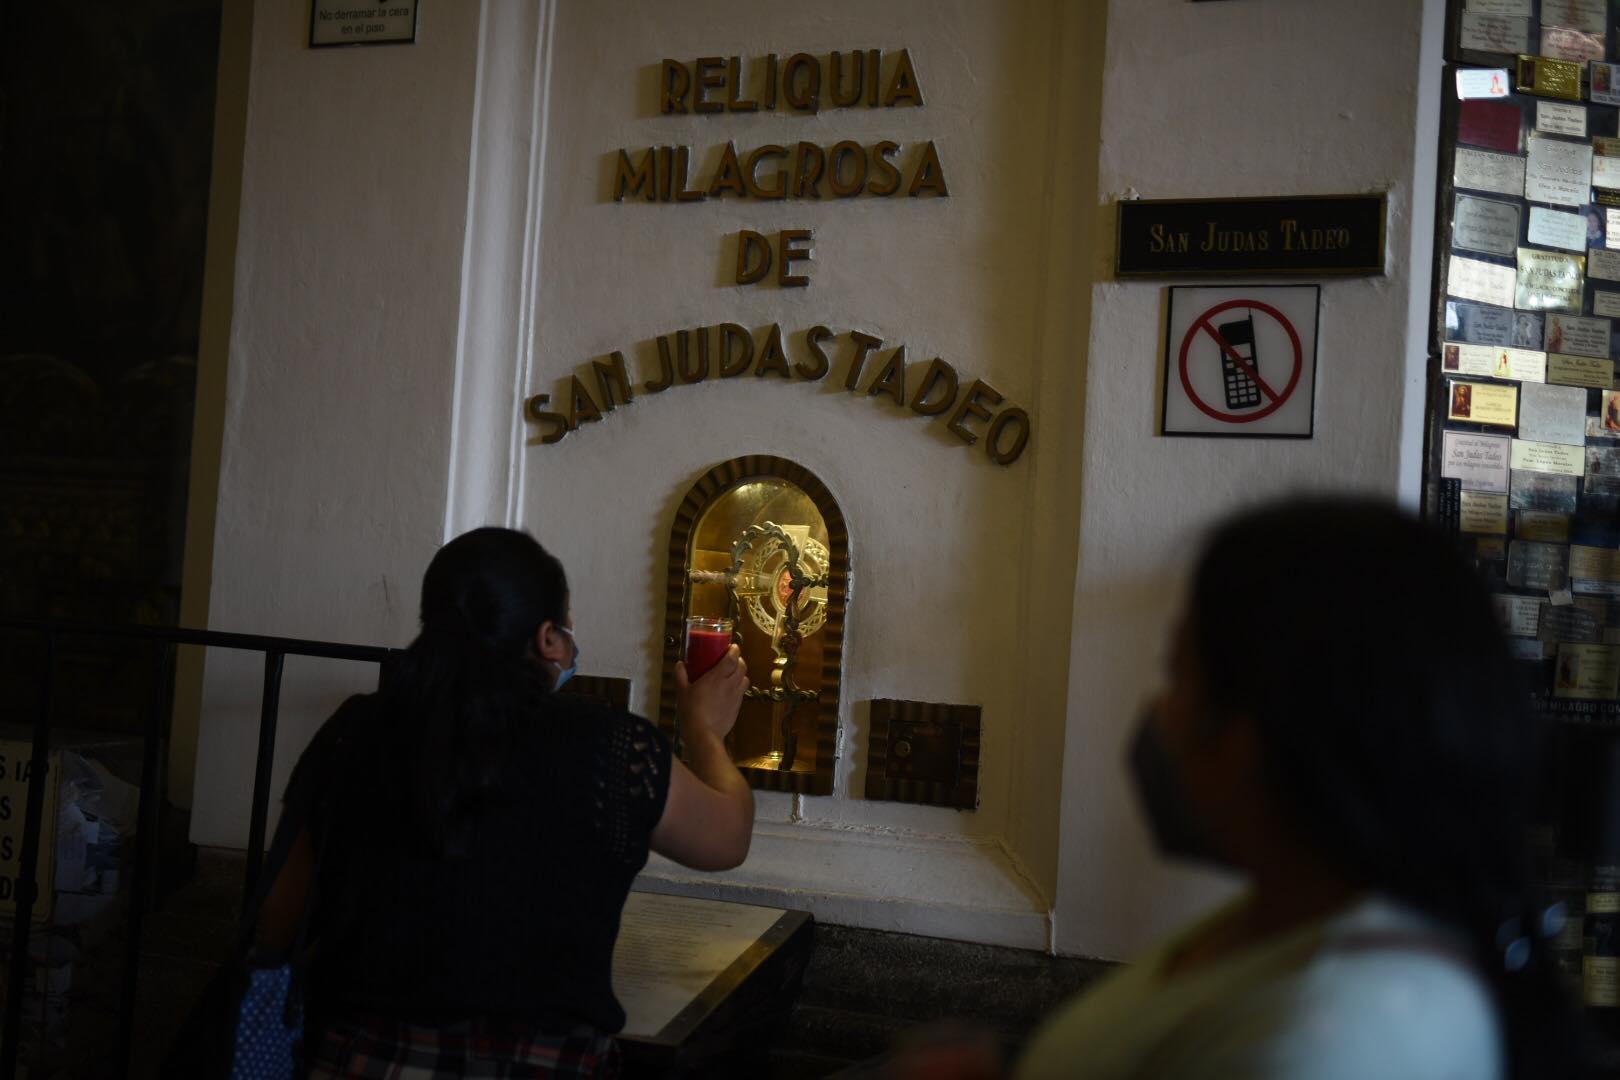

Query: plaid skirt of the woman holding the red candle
309;1017;619;1080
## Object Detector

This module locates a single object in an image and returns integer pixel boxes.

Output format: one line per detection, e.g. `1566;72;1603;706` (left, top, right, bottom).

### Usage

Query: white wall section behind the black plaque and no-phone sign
1056;0;1439;957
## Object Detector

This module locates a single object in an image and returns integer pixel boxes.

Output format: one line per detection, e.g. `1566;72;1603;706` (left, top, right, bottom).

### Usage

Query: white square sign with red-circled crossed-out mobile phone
1162;285;1322;439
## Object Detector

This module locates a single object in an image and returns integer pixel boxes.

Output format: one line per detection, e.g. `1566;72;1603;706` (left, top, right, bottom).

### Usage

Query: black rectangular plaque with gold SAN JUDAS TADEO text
1115;193;1385;277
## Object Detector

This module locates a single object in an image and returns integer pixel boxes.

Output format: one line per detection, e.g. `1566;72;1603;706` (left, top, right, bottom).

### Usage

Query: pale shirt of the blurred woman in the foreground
1014;899;1503;1080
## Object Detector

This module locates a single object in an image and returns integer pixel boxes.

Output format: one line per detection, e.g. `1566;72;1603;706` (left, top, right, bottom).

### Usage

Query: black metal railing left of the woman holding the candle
0;619;397;1080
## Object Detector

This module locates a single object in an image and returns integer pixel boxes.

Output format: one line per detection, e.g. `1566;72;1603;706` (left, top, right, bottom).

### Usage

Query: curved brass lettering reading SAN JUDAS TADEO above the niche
523;322;1030;465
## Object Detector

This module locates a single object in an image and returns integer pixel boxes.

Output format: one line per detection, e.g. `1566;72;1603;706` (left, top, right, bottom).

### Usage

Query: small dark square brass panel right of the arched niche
867;698;980;810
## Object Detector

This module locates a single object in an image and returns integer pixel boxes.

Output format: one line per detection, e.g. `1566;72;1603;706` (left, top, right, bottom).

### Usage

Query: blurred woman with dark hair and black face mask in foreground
1017;500;1583;1080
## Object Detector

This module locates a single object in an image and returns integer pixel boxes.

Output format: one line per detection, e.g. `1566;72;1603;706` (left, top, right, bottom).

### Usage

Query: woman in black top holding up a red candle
259;528;753;1077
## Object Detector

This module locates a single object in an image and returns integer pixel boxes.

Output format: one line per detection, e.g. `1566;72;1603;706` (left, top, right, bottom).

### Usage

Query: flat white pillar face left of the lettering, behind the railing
188;3;480;847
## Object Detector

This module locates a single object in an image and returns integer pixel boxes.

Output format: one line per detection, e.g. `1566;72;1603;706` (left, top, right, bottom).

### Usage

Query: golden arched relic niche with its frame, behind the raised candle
658;455;849;795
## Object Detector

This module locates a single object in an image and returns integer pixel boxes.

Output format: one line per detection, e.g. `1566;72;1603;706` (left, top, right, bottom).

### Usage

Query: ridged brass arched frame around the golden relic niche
658;453;849;795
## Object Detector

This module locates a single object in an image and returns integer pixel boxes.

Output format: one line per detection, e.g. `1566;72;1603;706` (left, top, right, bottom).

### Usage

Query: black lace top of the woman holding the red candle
285;695;671;1033
